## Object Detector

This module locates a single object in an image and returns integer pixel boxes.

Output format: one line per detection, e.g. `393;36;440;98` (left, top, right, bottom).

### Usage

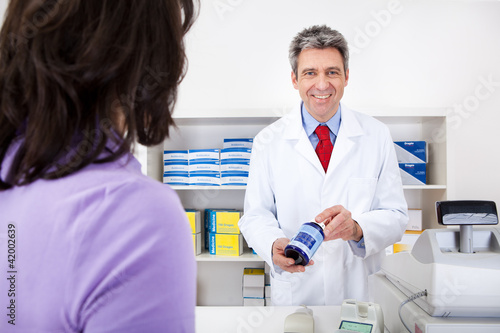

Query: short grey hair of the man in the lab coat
288;25;349;77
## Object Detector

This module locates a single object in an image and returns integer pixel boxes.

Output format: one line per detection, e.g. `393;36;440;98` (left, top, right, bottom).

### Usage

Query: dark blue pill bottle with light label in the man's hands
285;222;325;266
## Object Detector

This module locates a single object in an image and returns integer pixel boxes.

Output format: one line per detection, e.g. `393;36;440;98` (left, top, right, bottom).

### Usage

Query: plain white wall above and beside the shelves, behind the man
176;0;500;204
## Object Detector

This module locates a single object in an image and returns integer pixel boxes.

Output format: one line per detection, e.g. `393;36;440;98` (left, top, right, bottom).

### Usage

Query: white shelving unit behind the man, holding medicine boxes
147;108;447;305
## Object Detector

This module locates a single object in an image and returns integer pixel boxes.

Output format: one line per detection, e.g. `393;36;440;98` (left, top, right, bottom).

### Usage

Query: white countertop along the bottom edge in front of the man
196;306;340;333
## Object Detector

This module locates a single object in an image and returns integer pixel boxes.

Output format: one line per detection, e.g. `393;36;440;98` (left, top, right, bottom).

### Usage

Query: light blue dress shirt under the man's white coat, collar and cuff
301;103;366;257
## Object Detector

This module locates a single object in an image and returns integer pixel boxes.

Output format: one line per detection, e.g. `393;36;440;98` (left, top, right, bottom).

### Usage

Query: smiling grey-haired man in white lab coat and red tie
240;26;408;305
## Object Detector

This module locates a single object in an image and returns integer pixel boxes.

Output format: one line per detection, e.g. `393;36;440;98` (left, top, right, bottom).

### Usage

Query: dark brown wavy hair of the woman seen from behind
0;0;196;190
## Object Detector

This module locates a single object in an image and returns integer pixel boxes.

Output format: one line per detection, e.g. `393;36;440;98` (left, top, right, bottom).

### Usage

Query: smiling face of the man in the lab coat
292;48;349;122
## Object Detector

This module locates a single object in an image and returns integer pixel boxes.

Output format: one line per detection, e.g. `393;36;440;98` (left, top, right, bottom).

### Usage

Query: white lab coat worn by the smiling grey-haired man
239;104;408;305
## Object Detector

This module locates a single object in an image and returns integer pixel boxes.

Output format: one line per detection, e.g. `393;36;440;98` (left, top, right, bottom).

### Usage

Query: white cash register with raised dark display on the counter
370;201;500;333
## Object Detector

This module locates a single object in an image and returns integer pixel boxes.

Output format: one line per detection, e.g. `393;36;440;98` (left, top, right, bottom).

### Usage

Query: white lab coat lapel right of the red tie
327;104;364;175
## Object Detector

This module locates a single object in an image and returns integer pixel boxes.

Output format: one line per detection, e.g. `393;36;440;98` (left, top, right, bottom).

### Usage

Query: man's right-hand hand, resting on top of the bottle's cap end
314;205;363;242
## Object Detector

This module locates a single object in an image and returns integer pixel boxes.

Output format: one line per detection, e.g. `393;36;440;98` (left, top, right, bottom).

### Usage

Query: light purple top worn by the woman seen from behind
0;137;196;333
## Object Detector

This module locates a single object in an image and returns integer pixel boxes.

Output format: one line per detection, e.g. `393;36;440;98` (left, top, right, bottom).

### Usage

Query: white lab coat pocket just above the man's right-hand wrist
346;178;377;214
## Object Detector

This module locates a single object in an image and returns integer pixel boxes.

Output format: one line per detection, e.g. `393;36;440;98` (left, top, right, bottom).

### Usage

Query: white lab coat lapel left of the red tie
283;104;324;174
